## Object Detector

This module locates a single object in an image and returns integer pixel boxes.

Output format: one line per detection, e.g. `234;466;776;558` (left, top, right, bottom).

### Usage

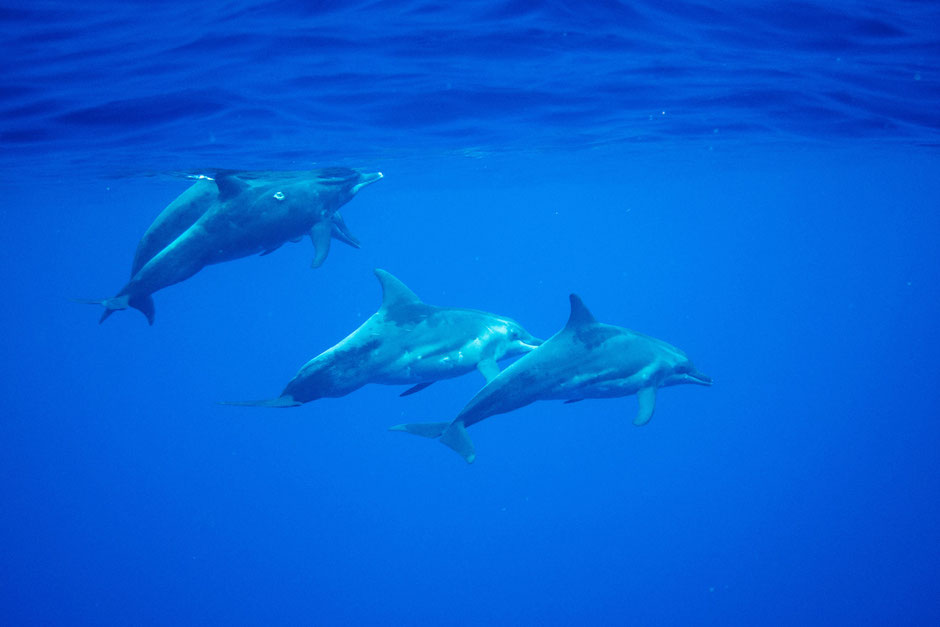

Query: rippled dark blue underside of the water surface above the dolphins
0;0;940;172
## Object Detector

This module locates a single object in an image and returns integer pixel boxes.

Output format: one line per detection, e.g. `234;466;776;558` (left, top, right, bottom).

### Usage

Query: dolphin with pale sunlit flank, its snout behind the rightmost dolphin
223;269;542;407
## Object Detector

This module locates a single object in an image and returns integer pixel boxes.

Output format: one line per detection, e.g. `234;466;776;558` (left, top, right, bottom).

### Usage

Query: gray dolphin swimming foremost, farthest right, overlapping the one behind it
391;294;712;463
